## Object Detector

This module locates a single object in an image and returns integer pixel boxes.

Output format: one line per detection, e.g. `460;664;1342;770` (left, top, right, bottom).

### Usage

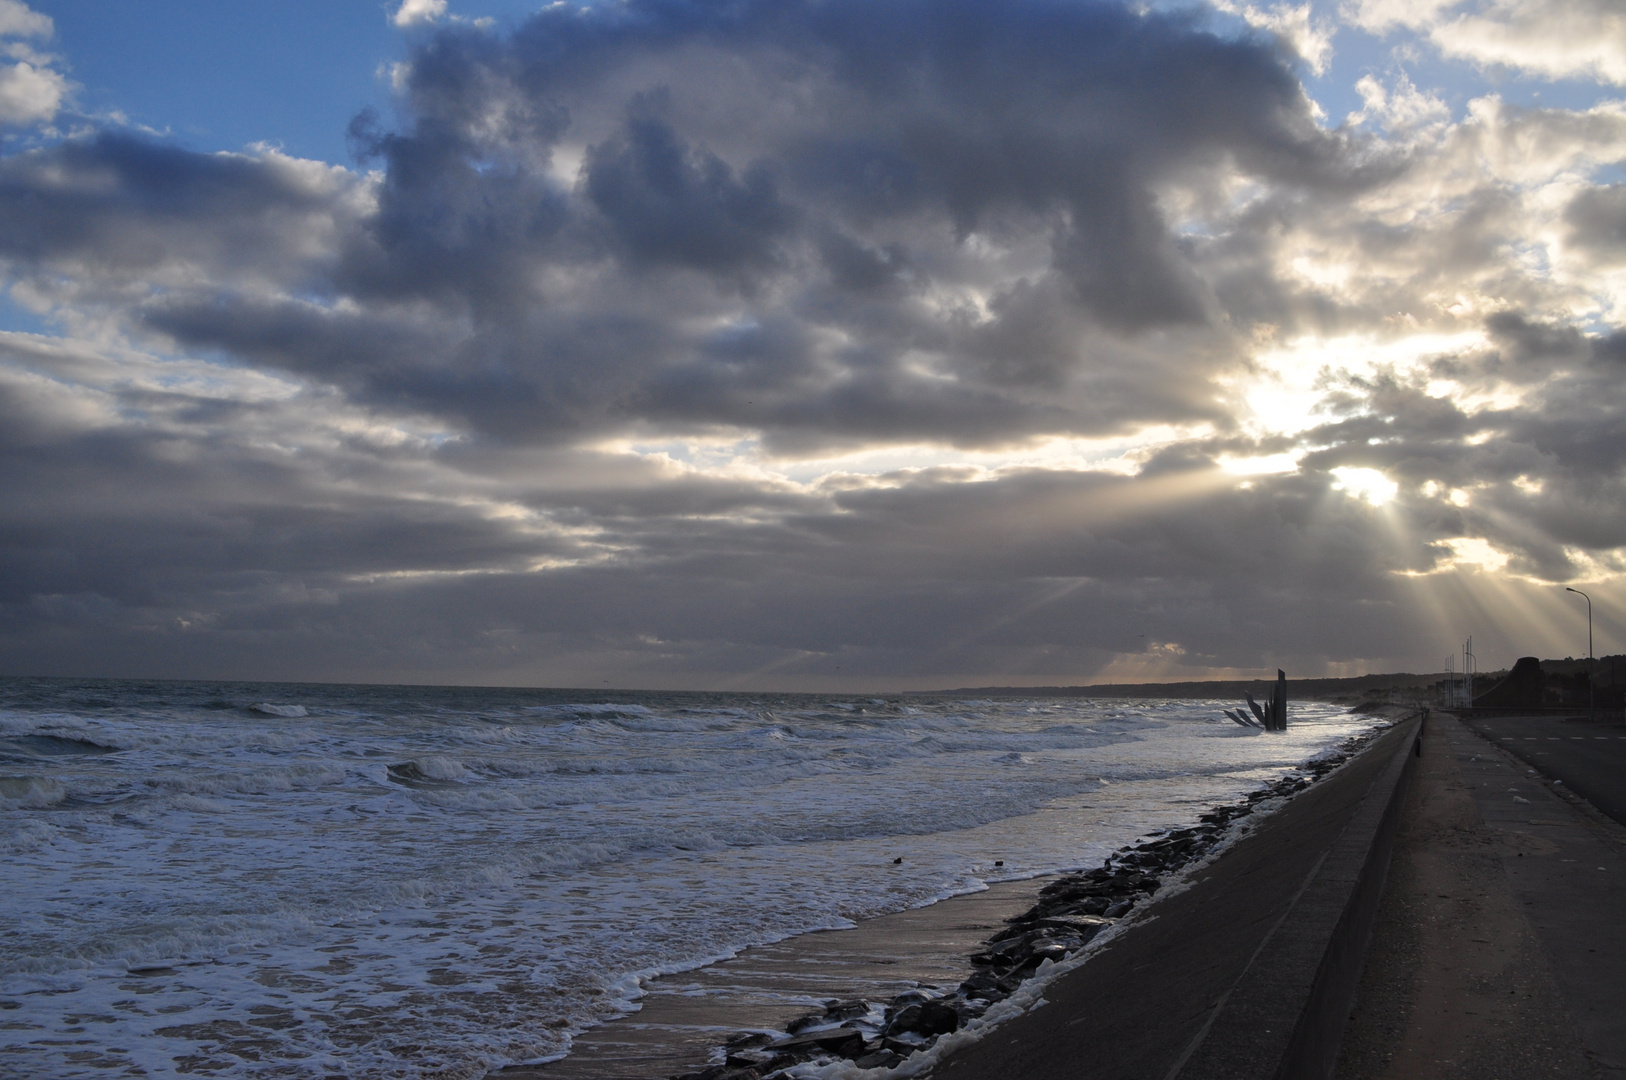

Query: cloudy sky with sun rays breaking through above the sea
0;0;1626;693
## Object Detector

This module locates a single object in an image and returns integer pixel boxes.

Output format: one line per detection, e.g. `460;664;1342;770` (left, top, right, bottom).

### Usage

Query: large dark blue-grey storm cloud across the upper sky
0;0;1348;447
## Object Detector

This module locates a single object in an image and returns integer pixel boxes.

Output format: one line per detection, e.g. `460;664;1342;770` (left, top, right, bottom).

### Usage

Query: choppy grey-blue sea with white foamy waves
0;678;1376;1078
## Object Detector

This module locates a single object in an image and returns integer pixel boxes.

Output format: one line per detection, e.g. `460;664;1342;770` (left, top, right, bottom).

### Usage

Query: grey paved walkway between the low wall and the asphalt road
1337;714;1626;1080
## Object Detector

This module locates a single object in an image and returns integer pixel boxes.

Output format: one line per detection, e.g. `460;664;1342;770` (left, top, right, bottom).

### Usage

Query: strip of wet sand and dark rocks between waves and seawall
500;712;1389;1080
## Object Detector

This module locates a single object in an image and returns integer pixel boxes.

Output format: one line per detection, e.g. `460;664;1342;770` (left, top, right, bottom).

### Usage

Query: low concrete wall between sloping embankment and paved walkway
1174;719;1421;1080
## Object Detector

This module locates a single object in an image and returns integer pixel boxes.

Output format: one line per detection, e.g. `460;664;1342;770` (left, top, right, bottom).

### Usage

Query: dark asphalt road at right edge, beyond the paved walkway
1463;716;1626;825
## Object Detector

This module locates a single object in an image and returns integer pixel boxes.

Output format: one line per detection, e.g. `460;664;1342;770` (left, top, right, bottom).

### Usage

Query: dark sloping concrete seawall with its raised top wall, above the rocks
933;716;1419;1080
